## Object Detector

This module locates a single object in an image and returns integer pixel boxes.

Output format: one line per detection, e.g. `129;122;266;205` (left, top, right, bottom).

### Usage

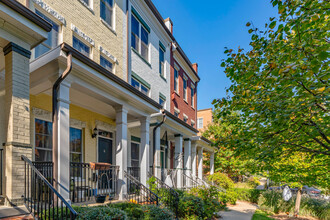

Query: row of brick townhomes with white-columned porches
0;0;214;217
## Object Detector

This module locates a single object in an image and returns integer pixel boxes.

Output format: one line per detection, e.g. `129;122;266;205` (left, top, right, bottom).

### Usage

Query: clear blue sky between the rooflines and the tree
153;0;277;109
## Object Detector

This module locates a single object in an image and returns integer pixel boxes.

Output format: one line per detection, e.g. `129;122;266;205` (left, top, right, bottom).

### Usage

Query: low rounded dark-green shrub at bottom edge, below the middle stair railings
142;205;174;220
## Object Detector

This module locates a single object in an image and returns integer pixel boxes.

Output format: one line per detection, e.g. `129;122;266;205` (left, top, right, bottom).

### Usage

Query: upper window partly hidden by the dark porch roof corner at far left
34;10;59;58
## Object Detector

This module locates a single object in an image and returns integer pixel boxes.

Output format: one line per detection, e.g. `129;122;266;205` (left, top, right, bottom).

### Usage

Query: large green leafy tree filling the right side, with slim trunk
213;0;330;214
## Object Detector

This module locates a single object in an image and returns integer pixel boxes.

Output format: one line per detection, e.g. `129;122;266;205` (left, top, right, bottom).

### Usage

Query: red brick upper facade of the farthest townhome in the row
171;47;197;128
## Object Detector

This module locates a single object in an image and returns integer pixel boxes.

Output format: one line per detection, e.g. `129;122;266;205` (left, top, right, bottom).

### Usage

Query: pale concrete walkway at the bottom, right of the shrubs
219;201;258;220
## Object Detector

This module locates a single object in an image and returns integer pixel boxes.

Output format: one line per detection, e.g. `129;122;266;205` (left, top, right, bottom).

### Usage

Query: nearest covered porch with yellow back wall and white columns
30;44;161;203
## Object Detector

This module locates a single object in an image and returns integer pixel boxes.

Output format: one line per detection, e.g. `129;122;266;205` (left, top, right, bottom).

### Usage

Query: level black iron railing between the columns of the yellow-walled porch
70;162;119;203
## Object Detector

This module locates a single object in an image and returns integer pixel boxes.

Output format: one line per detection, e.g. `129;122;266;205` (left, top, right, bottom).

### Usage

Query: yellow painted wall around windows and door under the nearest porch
30;94;116;162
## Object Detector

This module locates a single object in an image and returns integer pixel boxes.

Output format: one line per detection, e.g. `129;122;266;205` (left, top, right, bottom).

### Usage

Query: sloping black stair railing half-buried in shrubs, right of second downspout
148;172;179;217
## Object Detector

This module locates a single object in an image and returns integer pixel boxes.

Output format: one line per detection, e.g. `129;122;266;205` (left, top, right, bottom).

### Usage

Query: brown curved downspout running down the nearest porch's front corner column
52;52;72;186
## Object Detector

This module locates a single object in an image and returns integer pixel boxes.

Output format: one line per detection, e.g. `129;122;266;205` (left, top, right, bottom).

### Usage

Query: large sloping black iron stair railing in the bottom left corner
21;156;77;219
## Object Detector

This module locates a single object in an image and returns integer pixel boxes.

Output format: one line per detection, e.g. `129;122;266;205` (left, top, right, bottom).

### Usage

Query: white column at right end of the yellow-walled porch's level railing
116;106;128;200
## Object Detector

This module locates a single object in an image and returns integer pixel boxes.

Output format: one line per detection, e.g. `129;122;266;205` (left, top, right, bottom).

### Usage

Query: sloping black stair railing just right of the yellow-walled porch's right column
124;171;159;205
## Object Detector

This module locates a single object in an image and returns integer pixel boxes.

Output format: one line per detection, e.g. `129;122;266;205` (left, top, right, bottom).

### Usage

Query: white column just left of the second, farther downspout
140;117;150;186
